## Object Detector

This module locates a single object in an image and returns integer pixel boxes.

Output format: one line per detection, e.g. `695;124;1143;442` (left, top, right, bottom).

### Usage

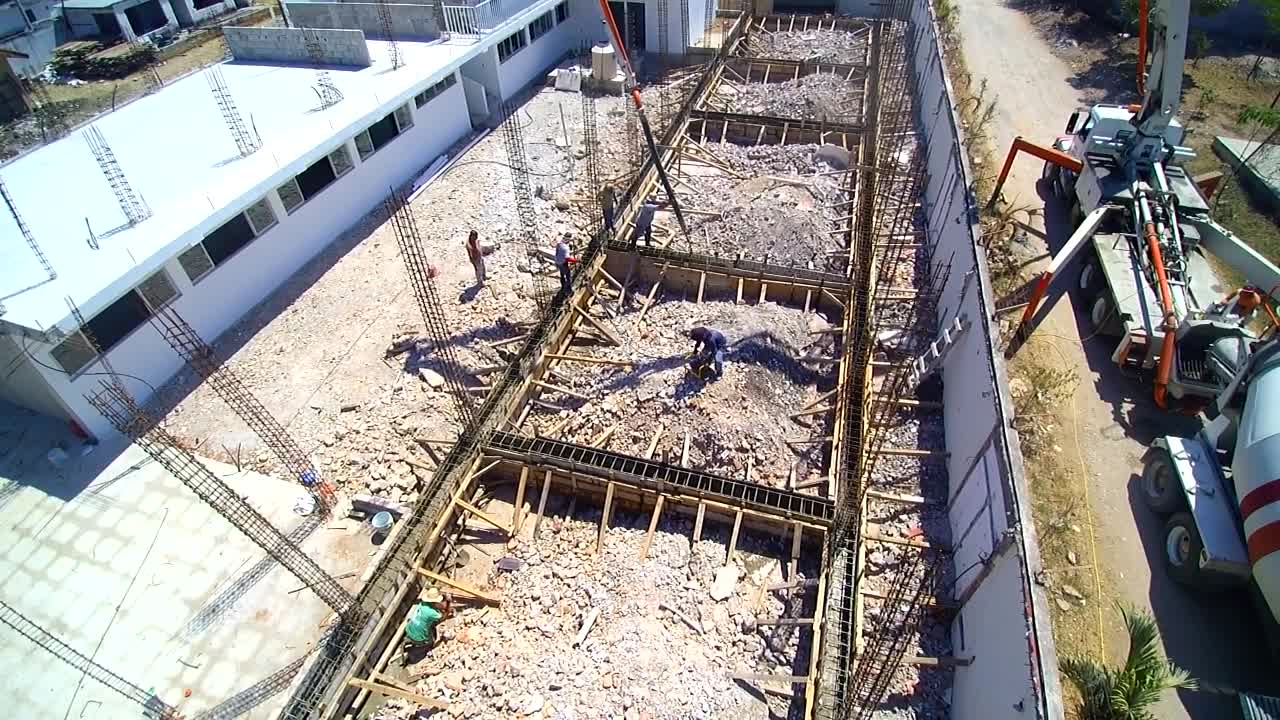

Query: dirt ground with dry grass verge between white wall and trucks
957;0;1275;720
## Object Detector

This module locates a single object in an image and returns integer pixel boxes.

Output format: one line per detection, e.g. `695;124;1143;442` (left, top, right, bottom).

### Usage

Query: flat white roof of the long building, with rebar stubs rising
0;40;476;332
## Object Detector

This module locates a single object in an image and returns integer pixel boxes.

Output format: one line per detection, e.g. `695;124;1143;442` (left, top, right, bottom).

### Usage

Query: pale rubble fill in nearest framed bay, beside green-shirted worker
387;498;818;720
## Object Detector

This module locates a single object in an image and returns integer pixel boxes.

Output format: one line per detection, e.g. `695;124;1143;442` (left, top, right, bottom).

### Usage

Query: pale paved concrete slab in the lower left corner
0;407;372;720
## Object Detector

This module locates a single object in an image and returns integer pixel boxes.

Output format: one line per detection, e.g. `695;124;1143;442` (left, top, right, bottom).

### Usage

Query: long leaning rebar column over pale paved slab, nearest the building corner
84;382;355;618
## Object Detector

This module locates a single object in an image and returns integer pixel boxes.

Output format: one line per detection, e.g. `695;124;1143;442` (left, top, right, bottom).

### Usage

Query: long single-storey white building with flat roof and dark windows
0;0;703;436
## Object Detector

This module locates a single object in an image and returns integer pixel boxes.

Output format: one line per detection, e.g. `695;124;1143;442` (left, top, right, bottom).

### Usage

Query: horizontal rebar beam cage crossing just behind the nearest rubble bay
485;432;836;527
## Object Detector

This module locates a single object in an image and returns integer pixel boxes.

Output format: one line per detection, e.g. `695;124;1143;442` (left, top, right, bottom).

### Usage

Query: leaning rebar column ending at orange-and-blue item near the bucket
151;302;334;515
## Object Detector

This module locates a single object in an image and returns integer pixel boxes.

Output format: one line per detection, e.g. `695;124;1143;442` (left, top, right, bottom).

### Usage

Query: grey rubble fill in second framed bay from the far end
721;73;863;123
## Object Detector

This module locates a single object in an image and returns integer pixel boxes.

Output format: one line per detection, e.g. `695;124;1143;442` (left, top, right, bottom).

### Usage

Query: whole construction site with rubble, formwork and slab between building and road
0;0;1062;720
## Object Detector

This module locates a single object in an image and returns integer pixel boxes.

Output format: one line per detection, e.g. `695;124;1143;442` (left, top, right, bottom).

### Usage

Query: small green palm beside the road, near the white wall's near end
1062;606;1198;720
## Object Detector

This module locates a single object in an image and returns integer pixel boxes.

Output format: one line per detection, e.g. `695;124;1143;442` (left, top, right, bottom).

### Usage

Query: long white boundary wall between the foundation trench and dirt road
908;0;1062;720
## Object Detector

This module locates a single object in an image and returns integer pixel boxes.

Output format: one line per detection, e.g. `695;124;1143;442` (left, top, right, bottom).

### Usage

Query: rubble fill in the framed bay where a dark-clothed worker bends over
535;297;836;487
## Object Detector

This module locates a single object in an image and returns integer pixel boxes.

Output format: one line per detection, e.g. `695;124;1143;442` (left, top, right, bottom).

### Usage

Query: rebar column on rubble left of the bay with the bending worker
383;190;475;432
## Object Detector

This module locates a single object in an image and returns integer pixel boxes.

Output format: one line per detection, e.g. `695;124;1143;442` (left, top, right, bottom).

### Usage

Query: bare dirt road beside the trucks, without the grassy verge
957;0;1276;720
